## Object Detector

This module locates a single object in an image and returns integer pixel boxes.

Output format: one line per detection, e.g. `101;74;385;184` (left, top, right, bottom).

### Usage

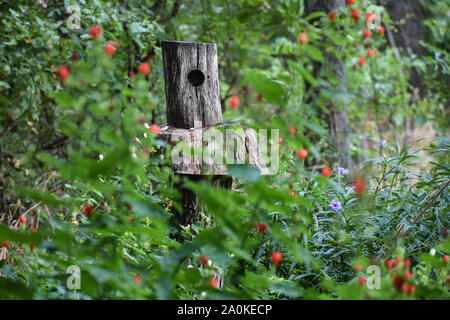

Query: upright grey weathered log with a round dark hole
162;41;222;129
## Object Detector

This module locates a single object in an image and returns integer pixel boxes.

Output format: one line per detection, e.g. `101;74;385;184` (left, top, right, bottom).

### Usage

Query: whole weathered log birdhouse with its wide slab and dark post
159;41;268;241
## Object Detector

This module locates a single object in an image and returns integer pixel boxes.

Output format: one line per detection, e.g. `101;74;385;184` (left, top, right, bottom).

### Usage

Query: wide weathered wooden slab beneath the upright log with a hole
159;124;270;175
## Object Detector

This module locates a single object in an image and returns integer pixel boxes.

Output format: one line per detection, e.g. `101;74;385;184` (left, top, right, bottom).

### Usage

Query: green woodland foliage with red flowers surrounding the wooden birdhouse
0;0;450;299
